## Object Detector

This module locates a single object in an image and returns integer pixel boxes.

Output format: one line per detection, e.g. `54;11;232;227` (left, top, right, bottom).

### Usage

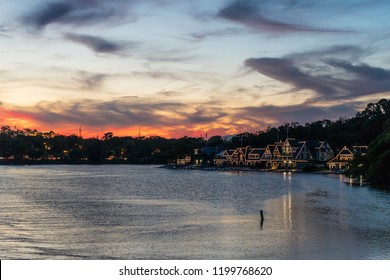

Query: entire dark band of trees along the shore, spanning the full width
0;99;390;188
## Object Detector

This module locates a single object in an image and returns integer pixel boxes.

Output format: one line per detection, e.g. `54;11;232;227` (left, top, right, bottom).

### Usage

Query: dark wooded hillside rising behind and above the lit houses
230;99;390;150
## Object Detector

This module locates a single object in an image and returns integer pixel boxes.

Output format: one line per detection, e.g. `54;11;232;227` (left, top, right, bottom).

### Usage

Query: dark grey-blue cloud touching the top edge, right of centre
217;0;345;33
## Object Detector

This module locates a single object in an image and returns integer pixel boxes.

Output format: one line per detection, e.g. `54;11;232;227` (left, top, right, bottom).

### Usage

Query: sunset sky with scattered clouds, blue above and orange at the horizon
0;0;390;138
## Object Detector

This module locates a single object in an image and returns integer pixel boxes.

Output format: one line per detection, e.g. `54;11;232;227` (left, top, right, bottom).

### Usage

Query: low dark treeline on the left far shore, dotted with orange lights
0;129;206;164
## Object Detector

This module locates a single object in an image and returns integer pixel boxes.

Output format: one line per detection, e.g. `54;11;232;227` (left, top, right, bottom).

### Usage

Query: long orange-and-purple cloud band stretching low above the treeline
2;96;372;136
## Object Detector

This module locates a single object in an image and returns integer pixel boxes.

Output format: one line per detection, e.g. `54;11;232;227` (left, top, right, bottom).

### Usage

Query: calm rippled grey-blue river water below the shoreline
0;165;390;259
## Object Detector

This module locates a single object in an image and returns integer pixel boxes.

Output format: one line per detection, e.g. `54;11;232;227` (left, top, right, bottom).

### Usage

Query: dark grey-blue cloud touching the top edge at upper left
23;0;132;30
